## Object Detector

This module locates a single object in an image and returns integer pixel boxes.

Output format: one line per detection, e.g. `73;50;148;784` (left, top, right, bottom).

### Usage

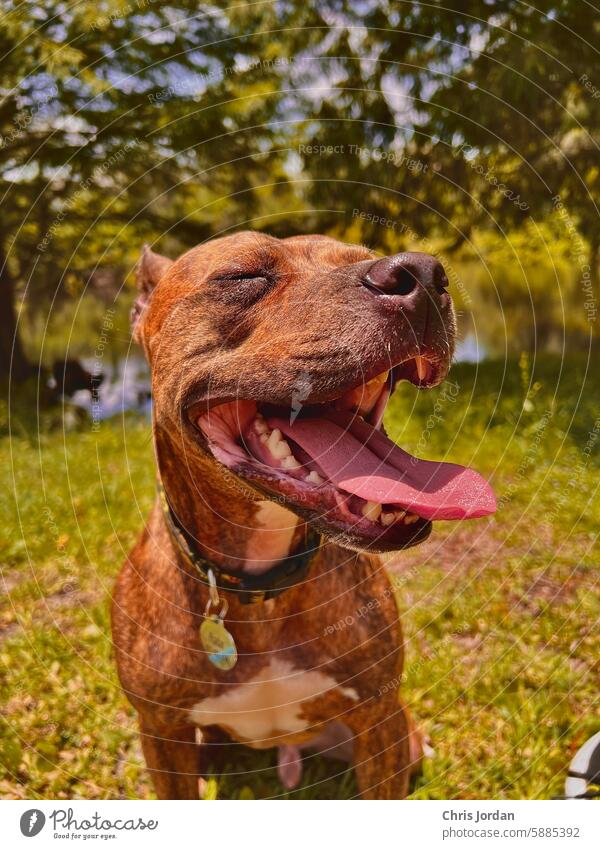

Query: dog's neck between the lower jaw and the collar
155;433;304;575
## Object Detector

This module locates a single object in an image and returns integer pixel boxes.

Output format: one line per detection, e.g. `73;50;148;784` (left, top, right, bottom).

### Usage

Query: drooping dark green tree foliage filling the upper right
290;0;600;318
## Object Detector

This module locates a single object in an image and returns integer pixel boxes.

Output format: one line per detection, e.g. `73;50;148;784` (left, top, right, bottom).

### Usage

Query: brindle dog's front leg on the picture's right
352;695;414;799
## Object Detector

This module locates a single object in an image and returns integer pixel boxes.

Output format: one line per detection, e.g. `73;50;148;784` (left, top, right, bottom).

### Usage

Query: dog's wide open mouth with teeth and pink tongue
195;357;496;550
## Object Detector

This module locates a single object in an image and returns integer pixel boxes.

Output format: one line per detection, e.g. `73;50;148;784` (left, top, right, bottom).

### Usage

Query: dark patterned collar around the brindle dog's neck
158;482;321;604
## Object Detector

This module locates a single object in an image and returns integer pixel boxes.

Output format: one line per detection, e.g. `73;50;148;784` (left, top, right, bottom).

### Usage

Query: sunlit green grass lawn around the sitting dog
0;358;600;799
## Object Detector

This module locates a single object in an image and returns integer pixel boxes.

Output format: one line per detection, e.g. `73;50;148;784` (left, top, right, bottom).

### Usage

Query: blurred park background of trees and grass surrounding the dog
0;0;600;798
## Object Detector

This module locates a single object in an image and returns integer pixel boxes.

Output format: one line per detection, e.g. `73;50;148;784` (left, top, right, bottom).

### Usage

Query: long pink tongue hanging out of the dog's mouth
268;413;496;519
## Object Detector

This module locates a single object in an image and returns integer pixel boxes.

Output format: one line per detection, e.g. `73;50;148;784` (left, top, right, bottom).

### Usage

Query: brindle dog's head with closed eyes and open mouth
133;232;495;551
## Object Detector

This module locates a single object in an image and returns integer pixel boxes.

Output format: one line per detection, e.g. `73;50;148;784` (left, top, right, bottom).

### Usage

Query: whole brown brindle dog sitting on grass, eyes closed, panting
112;231;495;799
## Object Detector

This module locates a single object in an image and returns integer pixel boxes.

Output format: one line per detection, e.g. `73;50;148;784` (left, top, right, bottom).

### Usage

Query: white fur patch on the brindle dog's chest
191;660;359;749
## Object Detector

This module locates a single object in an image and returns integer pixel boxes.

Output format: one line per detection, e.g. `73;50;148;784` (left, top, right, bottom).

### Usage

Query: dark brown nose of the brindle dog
364;251;448;296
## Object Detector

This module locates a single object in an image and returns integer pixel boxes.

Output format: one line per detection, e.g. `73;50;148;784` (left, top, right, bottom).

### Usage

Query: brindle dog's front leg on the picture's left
140;719;200;799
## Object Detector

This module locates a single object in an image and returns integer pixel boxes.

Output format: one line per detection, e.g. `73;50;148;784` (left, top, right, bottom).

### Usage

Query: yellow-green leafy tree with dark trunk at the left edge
0;0;292;380
